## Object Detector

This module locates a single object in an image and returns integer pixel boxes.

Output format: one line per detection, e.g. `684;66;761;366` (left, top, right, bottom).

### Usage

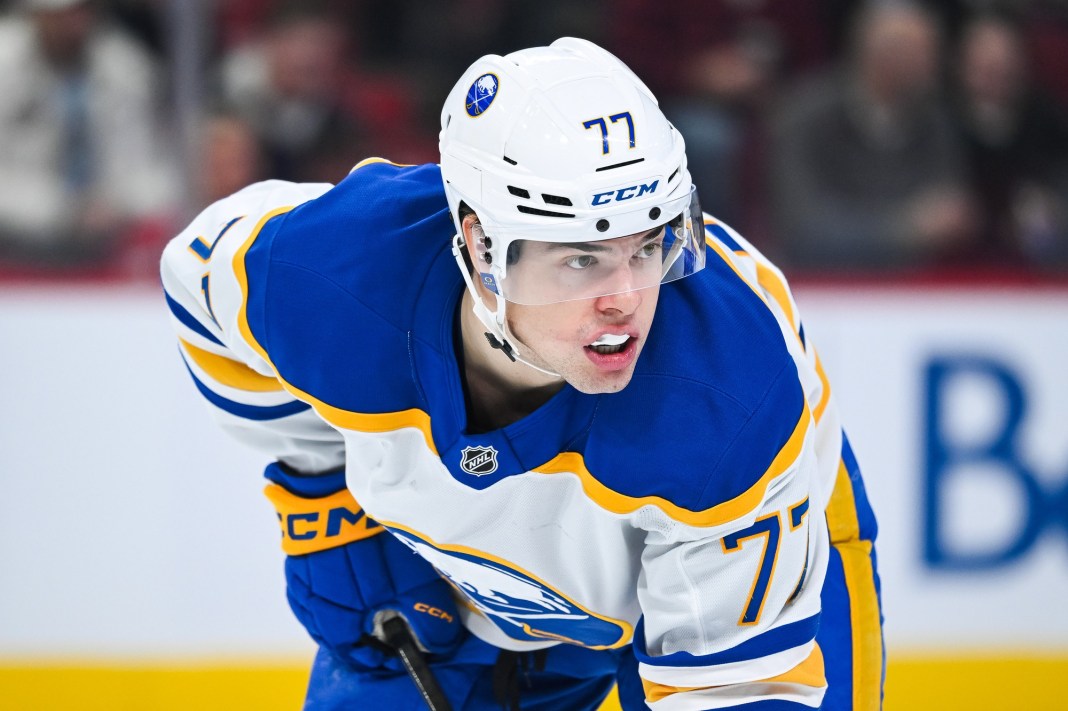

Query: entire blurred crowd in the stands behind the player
0;0;1068;279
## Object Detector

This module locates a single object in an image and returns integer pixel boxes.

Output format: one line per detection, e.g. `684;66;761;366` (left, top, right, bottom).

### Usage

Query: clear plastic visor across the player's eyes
480;183;705;305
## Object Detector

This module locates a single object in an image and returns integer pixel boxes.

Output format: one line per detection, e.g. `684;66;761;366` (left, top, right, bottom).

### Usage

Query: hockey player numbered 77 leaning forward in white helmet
162;38;882;711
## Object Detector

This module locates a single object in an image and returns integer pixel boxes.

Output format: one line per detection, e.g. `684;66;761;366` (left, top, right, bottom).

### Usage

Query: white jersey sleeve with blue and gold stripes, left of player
160;180;344;473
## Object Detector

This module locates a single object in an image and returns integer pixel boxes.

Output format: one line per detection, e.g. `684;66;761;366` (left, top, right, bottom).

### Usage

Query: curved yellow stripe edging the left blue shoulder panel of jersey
233;204;438;455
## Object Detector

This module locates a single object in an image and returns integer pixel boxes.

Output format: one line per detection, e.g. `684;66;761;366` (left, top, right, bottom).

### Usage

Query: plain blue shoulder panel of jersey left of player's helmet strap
246;163;459;412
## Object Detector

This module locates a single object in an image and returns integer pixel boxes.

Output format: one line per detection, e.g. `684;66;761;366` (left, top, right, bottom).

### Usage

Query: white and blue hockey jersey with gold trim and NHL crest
162;161;858;711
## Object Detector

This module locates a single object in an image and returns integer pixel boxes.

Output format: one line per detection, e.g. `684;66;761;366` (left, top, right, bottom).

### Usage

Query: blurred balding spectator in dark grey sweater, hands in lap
771;3;974;269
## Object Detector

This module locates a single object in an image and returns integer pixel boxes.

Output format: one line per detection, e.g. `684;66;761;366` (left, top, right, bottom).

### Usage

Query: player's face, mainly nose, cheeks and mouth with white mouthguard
506;235;662;394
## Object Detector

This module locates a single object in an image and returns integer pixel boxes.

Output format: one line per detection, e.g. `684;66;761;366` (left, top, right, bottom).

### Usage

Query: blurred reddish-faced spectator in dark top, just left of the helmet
212;2;367;183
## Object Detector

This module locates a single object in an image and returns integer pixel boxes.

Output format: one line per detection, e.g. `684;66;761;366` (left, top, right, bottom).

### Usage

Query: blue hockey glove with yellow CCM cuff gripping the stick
264;463;462;670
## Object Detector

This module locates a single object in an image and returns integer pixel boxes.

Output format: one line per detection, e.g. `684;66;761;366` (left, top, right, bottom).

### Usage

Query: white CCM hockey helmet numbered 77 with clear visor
439;37;705;365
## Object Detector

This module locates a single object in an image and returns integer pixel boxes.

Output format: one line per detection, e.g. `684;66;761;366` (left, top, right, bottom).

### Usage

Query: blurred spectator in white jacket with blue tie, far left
0;0;177;265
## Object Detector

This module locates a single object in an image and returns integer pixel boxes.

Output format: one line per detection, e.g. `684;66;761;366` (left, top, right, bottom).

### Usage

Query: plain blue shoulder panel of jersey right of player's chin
583;253;804;511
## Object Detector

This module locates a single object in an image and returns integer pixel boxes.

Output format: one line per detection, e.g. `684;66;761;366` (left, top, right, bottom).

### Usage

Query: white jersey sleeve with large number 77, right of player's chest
634;384;828;711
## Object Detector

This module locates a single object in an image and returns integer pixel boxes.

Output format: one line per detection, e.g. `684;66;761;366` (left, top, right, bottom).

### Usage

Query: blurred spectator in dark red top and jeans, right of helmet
606;0;829;243
